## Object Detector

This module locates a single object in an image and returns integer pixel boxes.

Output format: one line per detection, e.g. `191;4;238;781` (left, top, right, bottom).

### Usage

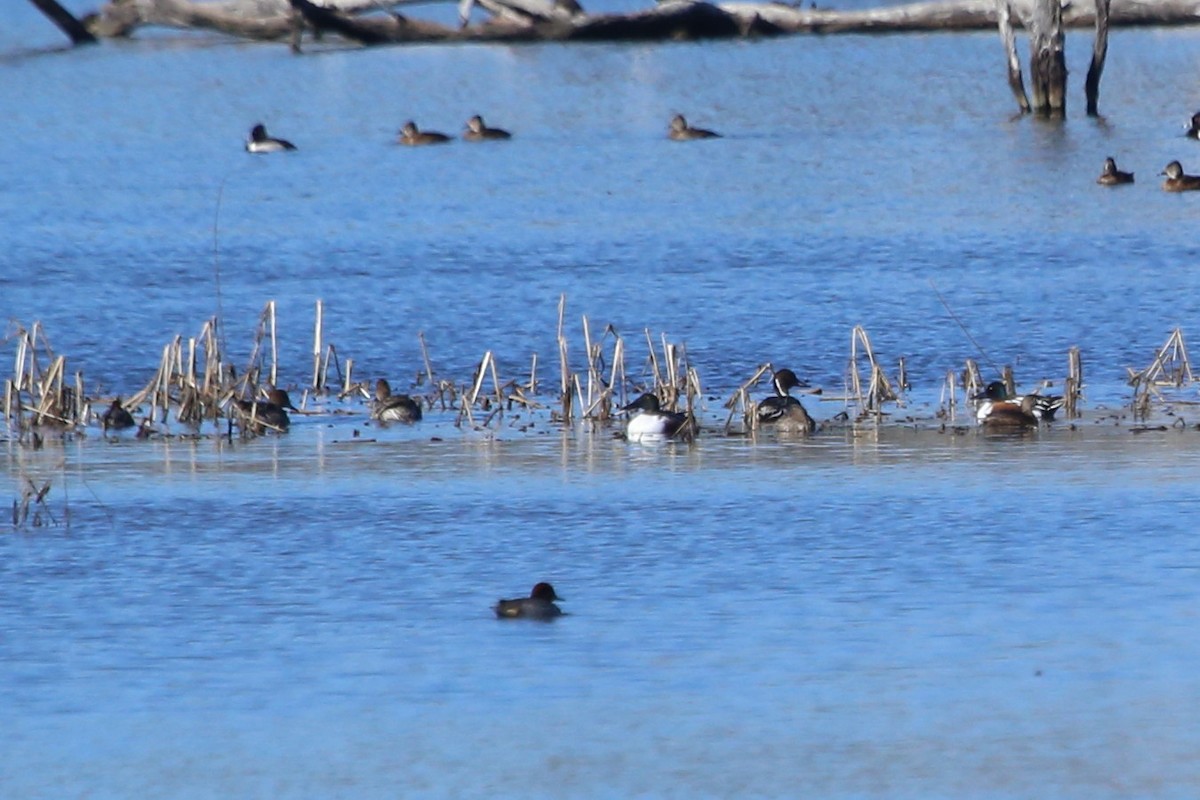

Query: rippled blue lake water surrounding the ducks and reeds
0;7;1200;799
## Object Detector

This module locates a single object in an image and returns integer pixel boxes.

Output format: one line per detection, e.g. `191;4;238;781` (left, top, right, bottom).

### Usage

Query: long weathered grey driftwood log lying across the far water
79;0;1200;43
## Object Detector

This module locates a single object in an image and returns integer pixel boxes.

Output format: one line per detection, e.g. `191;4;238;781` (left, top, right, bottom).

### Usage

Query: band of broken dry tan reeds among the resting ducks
4;295;1194;444
